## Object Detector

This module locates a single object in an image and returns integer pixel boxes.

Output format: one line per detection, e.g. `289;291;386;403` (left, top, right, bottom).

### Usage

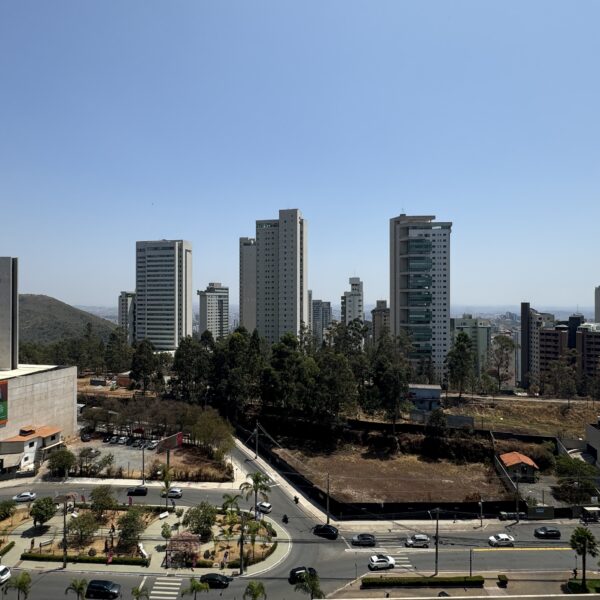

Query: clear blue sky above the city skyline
0;0;600;306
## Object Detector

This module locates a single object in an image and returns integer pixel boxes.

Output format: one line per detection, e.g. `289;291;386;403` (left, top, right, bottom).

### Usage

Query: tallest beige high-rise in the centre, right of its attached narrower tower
256;209;308;343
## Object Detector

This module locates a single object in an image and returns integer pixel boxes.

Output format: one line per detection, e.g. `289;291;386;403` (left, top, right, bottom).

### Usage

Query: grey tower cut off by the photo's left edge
0;256;19;371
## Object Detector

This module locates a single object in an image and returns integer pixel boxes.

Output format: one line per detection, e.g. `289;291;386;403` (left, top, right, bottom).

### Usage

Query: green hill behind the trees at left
19;294;116;344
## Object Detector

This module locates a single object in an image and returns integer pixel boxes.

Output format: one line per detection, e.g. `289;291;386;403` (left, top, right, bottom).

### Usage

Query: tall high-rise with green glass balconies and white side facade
390;214;452;378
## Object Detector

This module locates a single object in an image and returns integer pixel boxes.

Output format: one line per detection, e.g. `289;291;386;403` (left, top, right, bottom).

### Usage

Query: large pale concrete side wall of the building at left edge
0;367;77;439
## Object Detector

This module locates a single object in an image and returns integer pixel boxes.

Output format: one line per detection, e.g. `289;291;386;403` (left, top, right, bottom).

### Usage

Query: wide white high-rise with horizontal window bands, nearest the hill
135;240;192;350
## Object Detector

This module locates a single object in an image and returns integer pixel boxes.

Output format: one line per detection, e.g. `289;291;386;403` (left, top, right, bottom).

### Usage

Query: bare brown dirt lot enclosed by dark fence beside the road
276;446;506;502
